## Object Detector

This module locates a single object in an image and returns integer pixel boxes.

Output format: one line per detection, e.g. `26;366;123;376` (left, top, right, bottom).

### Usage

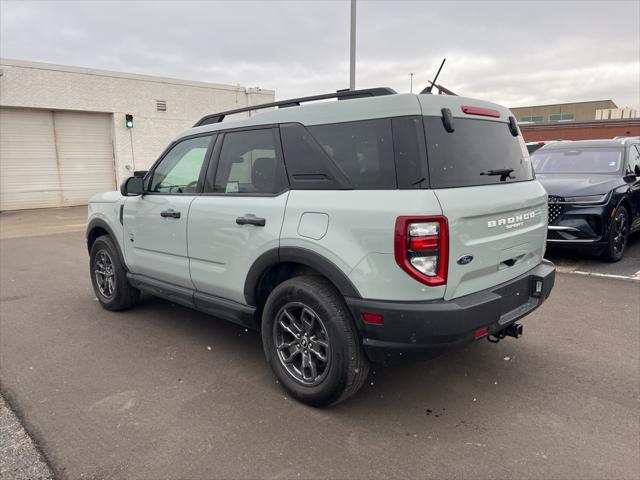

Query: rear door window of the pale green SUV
213;128;287;194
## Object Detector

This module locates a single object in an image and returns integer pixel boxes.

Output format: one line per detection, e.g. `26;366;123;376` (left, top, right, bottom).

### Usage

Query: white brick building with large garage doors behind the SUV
0;59;274;210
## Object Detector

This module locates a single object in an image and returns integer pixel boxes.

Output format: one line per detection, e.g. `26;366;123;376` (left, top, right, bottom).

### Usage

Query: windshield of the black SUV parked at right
531;147;622;173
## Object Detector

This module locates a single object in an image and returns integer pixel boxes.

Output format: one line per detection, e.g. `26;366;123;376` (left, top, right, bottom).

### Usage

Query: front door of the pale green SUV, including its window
123;134;212;288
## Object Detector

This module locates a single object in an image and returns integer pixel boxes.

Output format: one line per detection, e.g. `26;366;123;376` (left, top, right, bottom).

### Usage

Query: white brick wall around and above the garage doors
0;59;274;183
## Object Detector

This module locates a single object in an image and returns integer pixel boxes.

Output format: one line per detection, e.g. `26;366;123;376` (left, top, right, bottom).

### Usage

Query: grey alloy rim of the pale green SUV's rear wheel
273;302;331;386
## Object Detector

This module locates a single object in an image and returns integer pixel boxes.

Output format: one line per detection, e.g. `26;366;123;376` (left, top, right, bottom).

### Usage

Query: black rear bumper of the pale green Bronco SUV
346;260;555;363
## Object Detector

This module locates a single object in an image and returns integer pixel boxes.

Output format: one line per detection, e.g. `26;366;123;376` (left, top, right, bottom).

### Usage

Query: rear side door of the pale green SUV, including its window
188;127;289;304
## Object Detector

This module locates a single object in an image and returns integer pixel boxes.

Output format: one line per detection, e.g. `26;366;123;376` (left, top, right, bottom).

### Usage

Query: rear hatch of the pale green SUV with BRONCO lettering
420;96;547;300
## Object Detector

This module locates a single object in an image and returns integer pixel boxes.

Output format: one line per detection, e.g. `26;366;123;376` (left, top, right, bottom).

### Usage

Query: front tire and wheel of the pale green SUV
89;235;140;311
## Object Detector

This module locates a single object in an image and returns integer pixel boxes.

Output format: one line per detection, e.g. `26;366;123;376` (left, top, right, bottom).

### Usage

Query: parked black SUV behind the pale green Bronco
531;137;640;262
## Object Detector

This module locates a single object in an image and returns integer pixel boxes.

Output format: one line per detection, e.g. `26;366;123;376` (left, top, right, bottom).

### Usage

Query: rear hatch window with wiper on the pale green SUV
424;117;533;188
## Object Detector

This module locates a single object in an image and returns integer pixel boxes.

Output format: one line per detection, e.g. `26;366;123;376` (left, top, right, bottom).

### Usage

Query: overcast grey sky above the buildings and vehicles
0;0;640;109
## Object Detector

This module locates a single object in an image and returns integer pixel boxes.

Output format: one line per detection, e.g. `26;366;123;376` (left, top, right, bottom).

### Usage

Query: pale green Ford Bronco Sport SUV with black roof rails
87;88;555;406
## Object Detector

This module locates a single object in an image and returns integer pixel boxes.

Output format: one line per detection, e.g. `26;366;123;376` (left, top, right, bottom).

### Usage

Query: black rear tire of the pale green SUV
262;276;369;407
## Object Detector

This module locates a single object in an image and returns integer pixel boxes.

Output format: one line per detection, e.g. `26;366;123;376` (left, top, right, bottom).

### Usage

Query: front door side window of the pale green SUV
149;135;212;195
